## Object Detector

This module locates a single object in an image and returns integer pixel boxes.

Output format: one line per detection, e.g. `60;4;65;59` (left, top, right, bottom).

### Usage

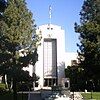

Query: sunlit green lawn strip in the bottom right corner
82;92;100;100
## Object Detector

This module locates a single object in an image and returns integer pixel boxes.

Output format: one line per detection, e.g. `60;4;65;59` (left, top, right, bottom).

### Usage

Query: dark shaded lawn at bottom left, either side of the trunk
0;92;28;100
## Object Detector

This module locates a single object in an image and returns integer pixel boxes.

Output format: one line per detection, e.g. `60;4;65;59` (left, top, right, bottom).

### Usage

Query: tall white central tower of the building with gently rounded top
35;24;65;88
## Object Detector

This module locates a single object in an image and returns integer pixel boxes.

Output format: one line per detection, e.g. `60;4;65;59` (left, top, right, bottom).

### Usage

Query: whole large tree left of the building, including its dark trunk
0;0;40;100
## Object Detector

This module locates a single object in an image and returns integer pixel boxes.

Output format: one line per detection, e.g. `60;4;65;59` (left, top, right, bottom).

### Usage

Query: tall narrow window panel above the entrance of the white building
43;39;57;85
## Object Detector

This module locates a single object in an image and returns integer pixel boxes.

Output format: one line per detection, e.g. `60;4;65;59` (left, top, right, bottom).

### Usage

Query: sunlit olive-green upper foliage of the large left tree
4;0;35;47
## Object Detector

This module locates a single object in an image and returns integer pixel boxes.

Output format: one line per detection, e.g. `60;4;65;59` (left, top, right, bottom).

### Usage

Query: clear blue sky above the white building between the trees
26;0;84;52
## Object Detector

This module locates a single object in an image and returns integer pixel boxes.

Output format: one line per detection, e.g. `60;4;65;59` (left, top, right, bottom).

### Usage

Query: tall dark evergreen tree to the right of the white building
75;0;100;90
